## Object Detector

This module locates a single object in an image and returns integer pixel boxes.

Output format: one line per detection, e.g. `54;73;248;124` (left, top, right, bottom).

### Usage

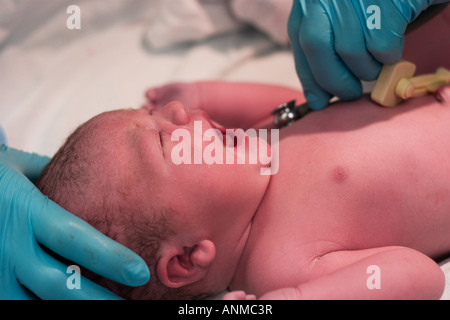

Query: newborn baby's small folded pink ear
156;240;216;288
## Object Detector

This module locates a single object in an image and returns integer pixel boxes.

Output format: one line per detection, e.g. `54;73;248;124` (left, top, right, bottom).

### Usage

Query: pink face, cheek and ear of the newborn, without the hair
86;102;270;296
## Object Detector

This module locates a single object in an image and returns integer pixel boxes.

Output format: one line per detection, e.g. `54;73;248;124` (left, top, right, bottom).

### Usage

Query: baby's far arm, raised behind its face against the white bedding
146;81;305;129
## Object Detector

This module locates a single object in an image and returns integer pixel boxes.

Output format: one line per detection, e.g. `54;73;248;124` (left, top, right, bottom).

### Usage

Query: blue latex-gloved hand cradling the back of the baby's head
0;145;150;299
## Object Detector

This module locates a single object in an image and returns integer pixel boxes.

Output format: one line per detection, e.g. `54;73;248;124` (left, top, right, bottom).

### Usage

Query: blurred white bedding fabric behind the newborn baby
0;0;450;299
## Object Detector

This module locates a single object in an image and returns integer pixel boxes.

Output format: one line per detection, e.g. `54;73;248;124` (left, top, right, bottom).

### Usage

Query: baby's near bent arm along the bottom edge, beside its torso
260;247;445;300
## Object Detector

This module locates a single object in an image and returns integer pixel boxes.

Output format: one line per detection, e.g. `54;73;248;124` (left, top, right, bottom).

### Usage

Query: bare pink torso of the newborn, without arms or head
234;96;450;296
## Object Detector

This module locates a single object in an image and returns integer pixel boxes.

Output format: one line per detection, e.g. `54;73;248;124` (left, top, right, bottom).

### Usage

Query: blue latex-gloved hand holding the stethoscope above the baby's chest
288;0;449;110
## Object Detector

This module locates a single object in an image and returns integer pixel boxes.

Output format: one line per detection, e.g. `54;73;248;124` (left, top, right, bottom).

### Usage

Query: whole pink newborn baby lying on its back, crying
38;82;450;299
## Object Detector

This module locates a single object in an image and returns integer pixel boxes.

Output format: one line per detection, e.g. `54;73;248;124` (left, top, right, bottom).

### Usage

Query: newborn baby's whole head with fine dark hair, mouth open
37;102;270;299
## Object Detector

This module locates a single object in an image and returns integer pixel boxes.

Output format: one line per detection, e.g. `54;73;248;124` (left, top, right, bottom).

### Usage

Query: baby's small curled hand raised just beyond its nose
145;82;201;109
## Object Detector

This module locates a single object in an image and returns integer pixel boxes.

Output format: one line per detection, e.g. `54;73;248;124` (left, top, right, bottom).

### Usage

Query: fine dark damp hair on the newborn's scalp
36;118;211;299
